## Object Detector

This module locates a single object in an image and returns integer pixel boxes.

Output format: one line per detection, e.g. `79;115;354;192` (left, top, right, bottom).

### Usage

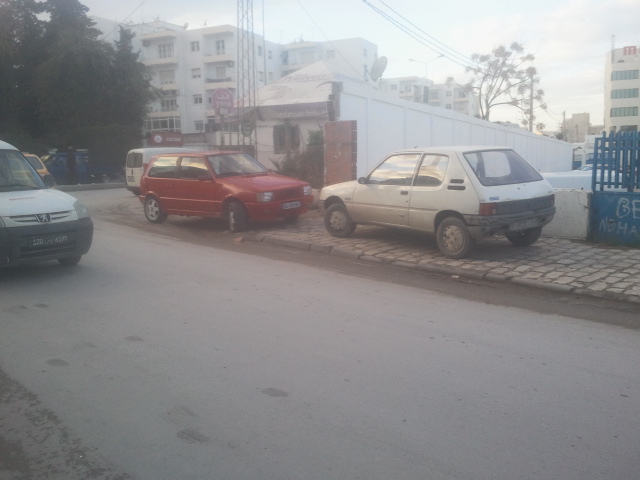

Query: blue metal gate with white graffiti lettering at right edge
589;132;640;248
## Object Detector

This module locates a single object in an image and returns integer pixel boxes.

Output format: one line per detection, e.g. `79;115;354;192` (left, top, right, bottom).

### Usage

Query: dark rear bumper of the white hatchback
464;206;556;239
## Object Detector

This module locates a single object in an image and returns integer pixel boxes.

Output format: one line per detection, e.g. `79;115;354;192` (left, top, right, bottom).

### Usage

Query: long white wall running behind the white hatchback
339;83;573;176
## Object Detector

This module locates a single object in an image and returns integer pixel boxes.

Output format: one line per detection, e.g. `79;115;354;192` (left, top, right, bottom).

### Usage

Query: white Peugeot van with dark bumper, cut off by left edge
0;140;93;267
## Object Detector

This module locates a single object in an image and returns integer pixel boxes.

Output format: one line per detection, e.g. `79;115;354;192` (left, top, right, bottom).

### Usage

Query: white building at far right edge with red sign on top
604;46;640;132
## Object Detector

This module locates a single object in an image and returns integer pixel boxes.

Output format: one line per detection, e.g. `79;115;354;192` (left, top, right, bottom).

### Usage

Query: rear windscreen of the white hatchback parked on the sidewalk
464;150;542;187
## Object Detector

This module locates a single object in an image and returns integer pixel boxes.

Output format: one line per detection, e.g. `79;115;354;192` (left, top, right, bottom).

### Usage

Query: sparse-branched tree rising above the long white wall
466;42;546;128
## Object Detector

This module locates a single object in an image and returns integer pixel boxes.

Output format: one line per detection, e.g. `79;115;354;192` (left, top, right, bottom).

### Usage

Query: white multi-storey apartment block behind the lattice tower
91;17;378;145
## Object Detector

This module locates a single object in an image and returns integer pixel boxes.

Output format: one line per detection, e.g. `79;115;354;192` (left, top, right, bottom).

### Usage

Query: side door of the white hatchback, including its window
349;153;421;226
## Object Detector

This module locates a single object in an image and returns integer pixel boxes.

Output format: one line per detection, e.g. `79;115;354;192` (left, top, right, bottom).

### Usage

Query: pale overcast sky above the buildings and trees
80;0;640;130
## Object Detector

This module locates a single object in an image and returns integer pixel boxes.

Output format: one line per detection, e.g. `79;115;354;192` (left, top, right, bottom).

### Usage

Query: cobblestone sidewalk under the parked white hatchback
243;210;640;303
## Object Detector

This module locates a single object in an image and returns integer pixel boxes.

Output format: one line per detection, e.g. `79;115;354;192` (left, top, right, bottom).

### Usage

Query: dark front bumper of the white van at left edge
0;218;93;267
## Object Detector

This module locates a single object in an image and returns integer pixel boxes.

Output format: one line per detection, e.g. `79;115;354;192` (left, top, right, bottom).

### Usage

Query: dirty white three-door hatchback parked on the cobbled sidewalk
320;146;555;258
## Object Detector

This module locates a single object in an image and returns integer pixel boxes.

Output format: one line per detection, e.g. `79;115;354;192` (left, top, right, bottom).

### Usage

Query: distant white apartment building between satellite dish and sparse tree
380;77;479;117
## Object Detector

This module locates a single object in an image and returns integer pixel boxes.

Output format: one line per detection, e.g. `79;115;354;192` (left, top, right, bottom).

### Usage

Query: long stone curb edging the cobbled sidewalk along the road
243;235;640;304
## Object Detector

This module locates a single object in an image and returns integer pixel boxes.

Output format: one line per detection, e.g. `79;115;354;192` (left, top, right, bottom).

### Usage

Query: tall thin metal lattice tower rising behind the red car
236;0;258;157
